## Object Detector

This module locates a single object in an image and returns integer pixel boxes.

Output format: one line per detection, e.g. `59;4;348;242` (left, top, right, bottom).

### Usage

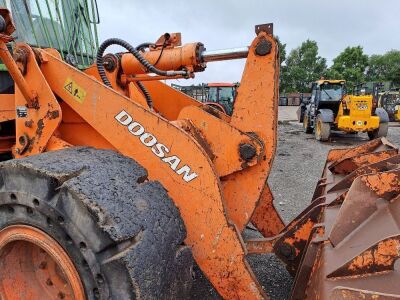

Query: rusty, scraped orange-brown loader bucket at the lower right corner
286;138;400;299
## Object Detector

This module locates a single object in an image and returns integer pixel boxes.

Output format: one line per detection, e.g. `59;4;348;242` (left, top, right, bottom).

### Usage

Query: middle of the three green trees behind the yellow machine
327;46;368;86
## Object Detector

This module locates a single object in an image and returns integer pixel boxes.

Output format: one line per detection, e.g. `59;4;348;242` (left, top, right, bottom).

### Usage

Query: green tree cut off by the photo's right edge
367;50;400;85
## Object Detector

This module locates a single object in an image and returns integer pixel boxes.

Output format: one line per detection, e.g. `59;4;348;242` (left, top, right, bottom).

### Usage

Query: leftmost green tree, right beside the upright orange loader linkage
281;40;326;93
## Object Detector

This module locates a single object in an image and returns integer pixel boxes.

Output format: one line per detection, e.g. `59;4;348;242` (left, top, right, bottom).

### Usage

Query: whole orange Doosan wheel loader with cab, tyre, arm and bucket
0;0;400;300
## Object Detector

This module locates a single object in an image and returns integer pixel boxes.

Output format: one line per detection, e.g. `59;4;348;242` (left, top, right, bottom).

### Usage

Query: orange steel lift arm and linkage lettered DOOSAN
0;9;283;299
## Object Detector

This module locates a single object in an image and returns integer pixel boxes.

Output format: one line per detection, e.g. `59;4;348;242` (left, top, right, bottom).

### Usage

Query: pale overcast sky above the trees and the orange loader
98;0;400;85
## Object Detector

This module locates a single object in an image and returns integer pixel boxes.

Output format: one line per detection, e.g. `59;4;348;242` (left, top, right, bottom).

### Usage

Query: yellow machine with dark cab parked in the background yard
297;79;389;141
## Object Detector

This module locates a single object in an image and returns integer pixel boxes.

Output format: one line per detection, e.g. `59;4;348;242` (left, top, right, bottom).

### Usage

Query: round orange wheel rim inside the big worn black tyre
0;225;85;300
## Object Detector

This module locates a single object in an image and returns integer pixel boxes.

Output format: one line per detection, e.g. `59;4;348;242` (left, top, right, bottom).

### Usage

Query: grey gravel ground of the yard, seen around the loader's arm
192;121;400;300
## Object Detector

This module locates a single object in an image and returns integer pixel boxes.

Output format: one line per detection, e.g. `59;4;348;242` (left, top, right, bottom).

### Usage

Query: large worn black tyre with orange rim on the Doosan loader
0;147;193;300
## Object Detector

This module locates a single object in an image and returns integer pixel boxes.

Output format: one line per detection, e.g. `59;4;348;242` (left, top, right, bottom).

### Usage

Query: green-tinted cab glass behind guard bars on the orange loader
0;0;99;69
